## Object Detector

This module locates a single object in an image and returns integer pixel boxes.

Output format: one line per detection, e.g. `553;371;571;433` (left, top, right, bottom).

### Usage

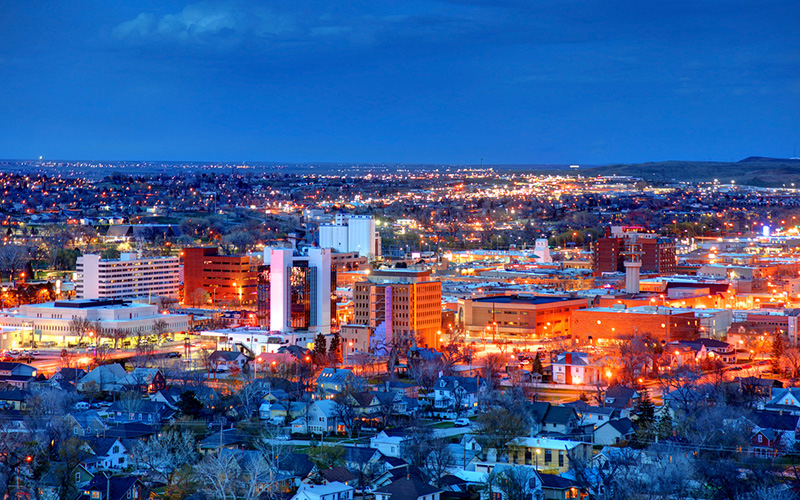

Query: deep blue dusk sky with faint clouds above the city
0;0;800;164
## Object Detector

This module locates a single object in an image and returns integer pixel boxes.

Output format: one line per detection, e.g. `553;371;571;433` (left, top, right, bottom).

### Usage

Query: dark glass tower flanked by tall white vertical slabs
256;248;335;335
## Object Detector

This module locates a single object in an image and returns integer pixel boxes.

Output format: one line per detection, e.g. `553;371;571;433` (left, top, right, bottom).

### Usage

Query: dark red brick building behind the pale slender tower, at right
592;227;678;276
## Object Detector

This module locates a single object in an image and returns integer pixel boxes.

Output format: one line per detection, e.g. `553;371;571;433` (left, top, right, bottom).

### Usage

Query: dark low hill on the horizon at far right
580;156;800;187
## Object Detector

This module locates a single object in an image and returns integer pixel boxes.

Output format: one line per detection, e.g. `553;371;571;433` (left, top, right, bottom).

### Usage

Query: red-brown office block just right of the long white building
183;247;256;306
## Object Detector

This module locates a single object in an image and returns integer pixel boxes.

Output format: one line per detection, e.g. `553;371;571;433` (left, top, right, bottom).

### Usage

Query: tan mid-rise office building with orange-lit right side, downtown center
353;269;442;348
